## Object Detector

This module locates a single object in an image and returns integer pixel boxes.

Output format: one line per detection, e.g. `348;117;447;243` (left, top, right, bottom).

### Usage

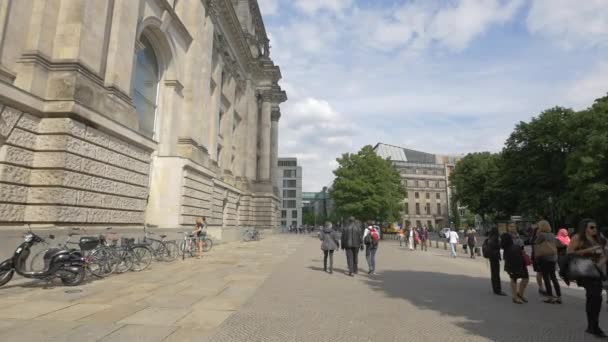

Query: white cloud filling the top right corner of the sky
527;0;608;48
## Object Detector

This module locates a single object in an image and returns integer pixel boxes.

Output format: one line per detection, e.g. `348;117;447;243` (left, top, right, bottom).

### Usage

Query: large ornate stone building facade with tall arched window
0;0;287;239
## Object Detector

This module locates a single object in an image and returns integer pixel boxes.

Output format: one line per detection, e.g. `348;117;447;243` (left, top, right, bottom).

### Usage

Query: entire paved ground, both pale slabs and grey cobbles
0;235;608;342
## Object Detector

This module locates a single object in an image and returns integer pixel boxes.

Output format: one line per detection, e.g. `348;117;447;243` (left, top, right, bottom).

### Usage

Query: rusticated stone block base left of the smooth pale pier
0;106;151;224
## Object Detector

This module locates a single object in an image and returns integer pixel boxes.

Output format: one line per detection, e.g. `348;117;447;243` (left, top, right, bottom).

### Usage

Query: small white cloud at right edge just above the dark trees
566;62;608;109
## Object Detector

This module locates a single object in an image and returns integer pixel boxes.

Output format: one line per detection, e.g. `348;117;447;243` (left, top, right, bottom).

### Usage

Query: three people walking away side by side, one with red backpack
318;217;380;277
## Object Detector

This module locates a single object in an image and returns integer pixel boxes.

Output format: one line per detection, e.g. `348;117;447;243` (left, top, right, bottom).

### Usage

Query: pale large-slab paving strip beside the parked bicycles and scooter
0;236;306;342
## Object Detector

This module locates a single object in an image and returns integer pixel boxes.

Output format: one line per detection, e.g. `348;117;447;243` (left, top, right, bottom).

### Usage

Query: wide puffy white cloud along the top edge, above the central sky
352;0;524;51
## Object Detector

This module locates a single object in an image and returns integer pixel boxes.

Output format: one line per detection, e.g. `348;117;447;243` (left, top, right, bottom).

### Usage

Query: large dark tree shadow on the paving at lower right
366;270;592;341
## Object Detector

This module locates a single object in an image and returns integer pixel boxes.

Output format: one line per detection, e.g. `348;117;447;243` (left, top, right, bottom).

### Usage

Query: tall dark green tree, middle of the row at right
501;107;576;224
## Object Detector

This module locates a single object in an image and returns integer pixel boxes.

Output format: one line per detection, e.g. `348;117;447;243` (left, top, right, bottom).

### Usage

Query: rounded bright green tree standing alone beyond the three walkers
331;145;405;222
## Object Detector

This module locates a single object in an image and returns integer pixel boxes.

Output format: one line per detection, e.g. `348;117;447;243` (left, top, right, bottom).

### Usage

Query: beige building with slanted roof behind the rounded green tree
374;143;457;228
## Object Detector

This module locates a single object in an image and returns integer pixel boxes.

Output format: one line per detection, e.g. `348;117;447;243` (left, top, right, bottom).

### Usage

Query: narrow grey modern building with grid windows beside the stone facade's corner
277;158;302;228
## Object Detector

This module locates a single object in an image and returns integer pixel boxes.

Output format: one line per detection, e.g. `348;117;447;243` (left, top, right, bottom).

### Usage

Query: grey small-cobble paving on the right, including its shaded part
205;239;608;342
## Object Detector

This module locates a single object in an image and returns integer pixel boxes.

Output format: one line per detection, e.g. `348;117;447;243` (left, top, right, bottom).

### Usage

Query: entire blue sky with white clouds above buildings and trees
259;0;608;191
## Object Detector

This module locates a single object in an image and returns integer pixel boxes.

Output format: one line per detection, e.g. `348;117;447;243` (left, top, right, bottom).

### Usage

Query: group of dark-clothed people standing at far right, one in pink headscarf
483;219;608;338
